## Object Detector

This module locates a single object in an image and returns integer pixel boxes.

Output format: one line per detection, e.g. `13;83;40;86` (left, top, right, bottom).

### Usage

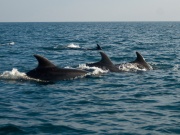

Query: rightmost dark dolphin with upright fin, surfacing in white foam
116;52;153;70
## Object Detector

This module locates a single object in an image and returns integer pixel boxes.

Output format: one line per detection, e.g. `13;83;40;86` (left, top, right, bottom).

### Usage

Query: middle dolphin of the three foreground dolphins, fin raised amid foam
86;52;121;72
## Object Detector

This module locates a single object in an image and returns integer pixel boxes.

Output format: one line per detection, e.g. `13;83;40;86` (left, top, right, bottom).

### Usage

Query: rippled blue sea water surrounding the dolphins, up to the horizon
0;22;180;135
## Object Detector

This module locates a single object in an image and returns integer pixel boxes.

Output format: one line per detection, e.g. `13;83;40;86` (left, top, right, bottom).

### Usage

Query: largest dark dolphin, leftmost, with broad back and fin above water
26;55;87;82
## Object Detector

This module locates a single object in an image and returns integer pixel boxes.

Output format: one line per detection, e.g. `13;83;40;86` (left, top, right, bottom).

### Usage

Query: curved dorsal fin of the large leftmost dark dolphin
34;54;56;68
